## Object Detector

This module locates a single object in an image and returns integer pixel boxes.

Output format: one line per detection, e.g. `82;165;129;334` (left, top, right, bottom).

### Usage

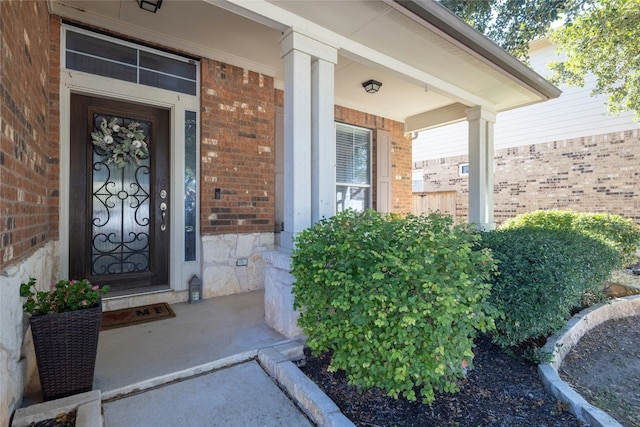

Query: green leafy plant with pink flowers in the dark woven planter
20;278;109;316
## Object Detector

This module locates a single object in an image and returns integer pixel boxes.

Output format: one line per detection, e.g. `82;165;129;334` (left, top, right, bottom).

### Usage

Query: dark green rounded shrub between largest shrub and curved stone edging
482;227;620;348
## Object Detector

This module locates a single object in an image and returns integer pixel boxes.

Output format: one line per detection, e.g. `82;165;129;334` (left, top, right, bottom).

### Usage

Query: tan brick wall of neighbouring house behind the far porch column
414;130;640;224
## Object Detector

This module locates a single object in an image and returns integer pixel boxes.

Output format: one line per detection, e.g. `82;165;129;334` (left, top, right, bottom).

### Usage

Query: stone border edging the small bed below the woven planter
11;390;103;427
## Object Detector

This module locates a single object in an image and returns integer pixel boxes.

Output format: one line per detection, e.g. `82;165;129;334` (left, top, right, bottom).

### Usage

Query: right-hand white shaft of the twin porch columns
311;59;336;224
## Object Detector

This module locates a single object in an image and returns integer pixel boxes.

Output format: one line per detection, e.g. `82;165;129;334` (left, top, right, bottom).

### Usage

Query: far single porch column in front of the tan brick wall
467;107;496;230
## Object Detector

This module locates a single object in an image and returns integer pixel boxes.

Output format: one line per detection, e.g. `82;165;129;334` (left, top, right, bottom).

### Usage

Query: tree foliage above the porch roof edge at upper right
440;0;640;119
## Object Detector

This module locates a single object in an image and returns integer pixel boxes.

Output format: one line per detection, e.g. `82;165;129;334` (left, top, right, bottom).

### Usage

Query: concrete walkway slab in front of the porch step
102;361;312;427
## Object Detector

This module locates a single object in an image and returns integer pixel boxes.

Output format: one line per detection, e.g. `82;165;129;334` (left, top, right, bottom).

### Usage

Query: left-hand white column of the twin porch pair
280;32;311;249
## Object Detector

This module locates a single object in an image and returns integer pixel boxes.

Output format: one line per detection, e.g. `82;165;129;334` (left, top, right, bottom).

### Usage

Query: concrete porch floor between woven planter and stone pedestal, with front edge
94;291;291;400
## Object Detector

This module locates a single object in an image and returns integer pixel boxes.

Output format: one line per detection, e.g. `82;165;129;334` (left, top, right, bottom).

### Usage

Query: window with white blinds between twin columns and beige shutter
336;123;371;212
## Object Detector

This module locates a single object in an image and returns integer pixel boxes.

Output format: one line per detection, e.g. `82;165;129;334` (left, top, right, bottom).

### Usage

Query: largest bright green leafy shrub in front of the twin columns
292;210;495;403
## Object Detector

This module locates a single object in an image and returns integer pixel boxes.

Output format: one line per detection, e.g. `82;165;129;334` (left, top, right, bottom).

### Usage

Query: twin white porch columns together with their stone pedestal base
264;30;338;337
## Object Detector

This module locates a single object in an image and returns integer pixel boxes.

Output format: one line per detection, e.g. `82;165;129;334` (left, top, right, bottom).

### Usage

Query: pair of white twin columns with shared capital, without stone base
280;30;338;249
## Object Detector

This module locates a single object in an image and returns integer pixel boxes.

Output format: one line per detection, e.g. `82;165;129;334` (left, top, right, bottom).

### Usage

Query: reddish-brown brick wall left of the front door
0;1;58;268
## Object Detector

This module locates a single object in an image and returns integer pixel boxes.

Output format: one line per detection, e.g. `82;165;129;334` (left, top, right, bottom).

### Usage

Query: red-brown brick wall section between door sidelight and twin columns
200;59;275;234
